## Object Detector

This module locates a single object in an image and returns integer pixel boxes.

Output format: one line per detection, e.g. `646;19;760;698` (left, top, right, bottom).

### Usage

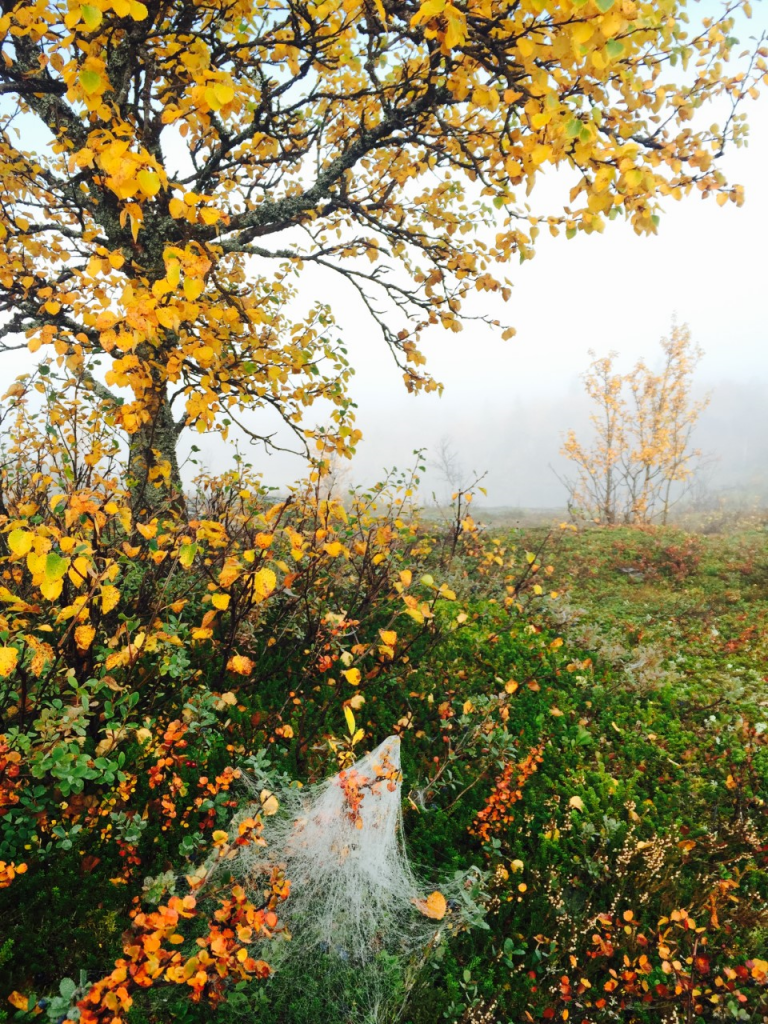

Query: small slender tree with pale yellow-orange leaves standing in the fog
562;324;710;523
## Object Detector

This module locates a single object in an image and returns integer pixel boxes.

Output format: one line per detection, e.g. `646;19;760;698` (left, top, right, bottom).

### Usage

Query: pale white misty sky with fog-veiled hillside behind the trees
0;11;768;507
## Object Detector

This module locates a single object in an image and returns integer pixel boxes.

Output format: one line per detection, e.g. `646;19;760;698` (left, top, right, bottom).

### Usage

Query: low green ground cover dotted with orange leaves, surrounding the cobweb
0;523;768;1024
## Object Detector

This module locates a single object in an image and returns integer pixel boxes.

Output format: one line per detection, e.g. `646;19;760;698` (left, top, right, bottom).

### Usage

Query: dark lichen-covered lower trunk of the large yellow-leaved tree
128;388;186;517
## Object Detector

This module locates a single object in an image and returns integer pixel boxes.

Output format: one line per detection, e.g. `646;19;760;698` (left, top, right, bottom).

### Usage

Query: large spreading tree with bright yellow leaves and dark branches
0;0;765;509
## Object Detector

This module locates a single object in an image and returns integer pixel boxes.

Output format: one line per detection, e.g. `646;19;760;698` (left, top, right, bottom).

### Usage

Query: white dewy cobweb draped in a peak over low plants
222;736;470;1024
